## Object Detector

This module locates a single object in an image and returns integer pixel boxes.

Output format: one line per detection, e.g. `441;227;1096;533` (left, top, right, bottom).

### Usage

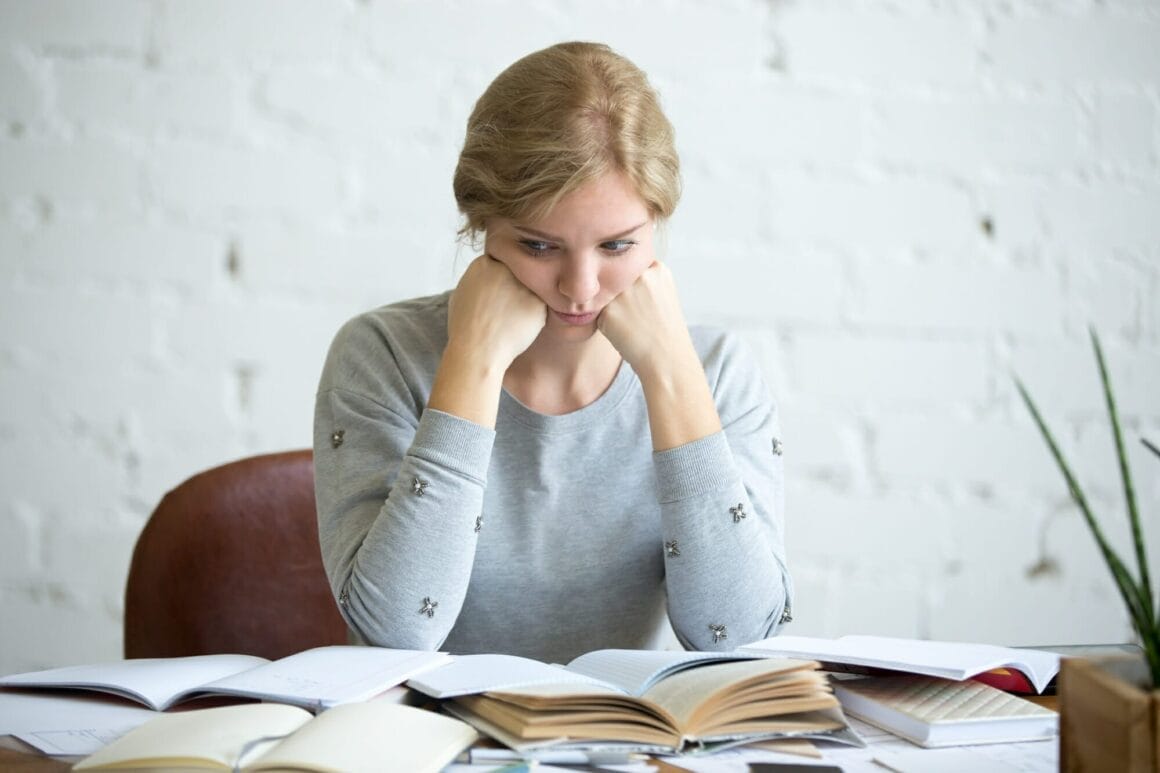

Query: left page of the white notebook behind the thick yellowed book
407;655;608;698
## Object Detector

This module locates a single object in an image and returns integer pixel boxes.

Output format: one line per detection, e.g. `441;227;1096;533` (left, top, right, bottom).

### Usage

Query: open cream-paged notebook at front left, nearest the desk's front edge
73;701;479;773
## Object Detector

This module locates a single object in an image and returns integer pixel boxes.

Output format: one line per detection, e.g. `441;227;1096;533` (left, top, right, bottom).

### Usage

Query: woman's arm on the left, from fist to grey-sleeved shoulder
314;258;546;649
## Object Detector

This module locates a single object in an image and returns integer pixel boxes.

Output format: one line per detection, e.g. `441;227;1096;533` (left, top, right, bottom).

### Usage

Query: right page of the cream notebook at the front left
245;701;479;773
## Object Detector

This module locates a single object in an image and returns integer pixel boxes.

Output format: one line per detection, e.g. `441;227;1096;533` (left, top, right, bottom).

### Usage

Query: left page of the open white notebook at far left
0;655;269;710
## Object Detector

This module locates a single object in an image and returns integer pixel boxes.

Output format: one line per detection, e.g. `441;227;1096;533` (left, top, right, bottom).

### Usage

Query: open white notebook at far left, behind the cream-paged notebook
0;645;451;711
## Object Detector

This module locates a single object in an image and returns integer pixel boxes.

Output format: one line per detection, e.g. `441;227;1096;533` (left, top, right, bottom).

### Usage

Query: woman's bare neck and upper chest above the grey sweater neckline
503;332;621;416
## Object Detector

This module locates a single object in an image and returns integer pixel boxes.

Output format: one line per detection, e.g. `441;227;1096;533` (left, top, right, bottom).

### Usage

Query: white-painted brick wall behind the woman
0;0;1160;672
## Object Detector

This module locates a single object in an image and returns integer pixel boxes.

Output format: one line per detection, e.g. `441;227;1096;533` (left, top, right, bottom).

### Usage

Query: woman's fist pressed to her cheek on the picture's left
448;254;548;373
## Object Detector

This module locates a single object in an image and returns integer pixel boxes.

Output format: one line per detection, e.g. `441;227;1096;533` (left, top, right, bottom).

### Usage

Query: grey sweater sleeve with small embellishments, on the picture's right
653;327;792;650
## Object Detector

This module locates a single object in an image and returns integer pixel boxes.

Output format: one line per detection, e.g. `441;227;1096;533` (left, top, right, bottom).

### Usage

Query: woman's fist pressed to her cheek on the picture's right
596;261;691;374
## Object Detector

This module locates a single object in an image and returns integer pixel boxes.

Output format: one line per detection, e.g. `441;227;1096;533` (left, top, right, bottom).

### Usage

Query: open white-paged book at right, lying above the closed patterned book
738;636;1059;693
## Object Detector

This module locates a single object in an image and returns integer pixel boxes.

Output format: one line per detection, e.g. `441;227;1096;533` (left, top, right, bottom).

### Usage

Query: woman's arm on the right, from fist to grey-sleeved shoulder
601;263;791;649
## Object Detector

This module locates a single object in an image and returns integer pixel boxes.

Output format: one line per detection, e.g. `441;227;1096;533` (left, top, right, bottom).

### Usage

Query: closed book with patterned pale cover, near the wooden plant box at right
834;674;1059;747
